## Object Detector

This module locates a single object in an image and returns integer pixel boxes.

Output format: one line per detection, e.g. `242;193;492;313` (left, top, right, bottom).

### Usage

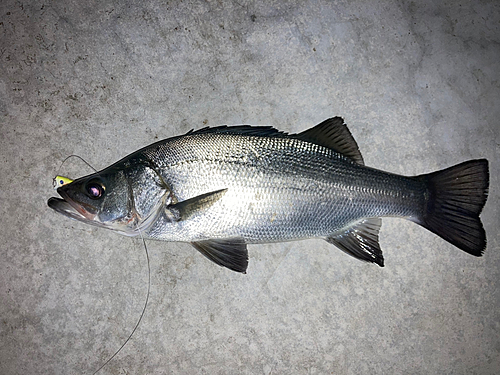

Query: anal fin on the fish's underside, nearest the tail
326;217;384;267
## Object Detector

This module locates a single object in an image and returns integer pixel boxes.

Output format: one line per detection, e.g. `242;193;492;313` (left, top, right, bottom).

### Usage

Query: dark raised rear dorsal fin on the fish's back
295;117;365;165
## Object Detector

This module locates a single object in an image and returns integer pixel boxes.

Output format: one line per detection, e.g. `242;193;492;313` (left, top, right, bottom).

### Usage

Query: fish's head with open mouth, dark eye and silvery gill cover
47;164;170;236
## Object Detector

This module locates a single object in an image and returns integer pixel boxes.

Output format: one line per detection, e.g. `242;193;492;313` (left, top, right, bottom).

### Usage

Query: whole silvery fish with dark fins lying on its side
48;117;489;273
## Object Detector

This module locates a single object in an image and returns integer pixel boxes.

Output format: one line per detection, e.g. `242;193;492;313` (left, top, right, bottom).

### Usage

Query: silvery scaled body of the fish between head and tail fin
145;134;425;243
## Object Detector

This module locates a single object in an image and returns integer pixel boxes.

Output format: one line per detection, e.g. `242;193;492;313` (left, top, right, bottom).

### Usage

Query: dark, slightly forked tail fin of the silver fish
414;159;489;256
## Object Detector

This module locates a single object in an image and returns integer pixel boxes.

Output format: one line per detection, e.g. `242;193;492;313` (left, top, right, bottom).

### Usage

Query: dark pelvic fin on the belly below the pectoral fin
191;238;248;273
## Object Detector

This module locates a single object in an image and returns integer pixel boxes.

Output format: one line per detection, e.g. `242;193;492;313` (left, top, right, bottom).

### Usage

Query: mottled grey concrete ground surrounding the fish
0;0;500;375
